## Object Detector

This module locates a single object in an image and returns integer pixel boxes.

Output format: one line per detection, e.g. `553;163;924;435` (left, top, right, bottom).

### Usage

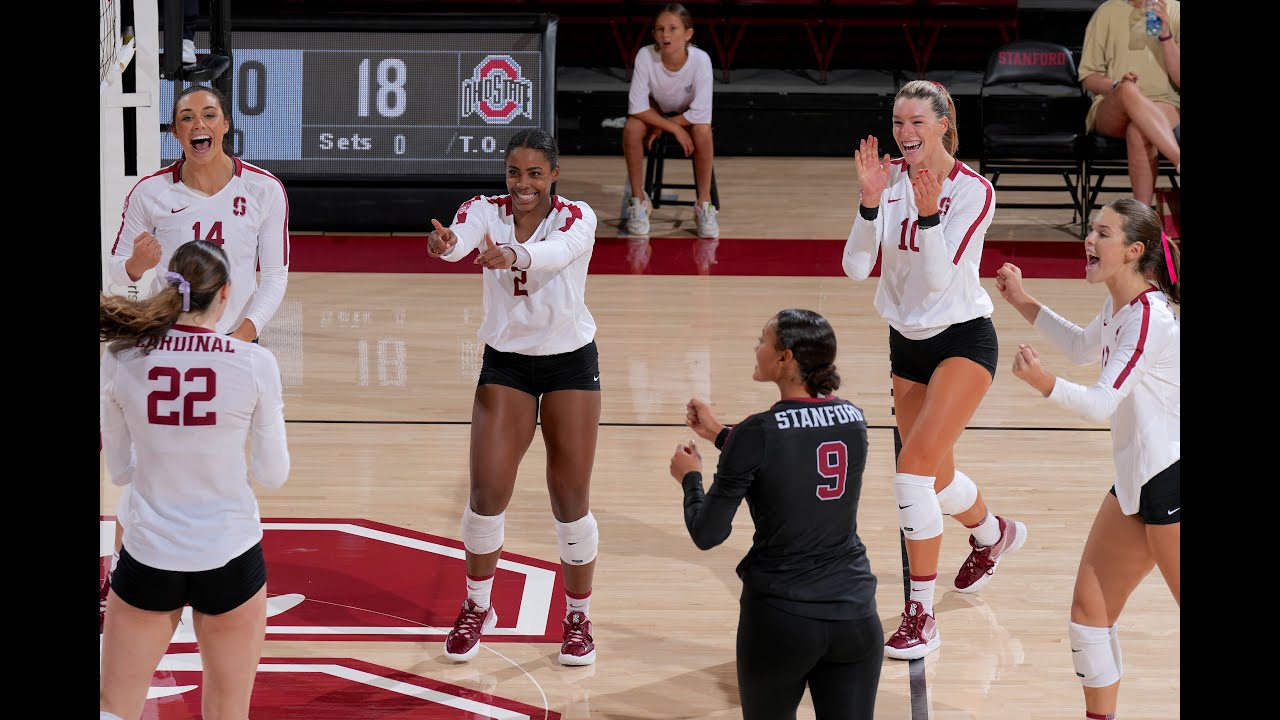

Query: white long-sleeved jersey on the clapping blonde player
842;158;996;340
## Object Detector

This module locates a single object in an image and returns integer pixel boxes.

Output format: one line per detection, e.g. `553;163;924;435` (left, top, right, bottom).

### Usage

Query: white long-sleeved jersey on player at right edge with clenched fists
1036;287;1181;515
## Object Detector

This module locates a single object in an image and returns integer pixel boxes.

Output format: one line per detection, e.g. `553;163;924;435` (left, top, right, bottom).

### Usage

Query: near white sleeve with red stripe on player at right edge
1048;301;1172;423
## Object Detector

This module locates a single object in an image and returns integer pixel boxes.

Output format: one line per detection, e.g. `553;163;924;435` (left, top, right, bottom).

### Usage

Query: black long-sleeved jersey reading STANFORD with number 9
682;396;876;620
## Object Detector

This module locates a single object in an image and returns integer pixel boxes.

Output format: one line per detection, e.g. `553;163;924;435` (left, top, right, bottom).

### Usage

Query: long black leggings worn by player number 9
737;593;884;720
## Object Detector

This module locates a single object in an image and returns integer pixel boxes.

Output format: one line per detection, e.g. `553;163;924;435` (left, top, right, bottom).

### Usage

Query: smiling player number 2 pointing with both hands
428;128;600;665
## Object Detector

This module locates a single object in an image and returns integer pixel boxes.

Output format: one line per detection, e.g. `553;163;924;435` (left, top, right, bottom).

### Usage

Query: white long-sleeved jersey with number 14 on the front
108;158;289;334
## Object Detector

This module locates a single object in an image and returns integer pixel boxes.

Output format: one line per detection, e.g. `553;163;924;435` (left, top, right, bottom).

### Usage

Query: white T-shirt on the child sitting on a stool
627;45;714;126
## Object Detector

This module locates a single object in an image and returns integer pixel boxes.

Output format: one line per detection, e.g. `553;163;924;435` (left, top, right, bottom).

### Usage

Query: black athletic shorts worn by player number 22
111;543;266;615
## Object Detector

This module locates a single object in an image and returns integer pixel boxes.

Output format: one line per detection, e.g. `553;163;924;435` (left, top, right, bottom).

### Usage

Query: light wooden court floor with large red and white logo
100;158;1180;720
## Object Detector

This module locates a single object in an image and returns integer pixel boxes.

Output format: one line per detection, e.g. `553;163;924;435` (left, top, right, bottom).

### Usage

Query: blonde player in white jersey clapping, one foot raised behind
844;81;1027;660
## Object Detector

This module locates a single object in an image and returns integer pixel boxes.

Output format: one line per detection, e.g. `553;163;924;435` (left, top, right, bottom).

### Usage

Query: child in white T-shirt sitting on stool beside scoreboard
622;3;719;237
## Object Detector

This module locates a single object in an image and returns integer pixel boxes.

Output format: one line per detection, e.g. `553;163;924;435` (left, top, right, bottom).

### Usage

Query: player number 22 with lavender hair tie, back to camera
99;241;289;717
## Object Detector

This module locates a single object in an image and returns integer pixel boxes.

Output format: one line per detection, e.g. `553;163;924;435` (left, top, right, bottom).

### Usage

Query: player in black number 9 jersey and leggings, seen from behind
671;310;884;720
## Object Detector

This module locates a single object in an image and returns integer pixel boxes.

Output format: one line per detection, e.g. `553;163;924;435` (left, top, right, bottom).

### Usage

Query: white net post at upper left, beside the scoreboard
97;0;160;296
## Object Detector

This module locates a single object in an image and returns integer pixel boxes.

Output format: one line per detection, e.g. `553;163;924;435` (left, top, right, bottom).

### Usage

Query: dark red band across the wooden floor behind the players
289;234;1084;278
